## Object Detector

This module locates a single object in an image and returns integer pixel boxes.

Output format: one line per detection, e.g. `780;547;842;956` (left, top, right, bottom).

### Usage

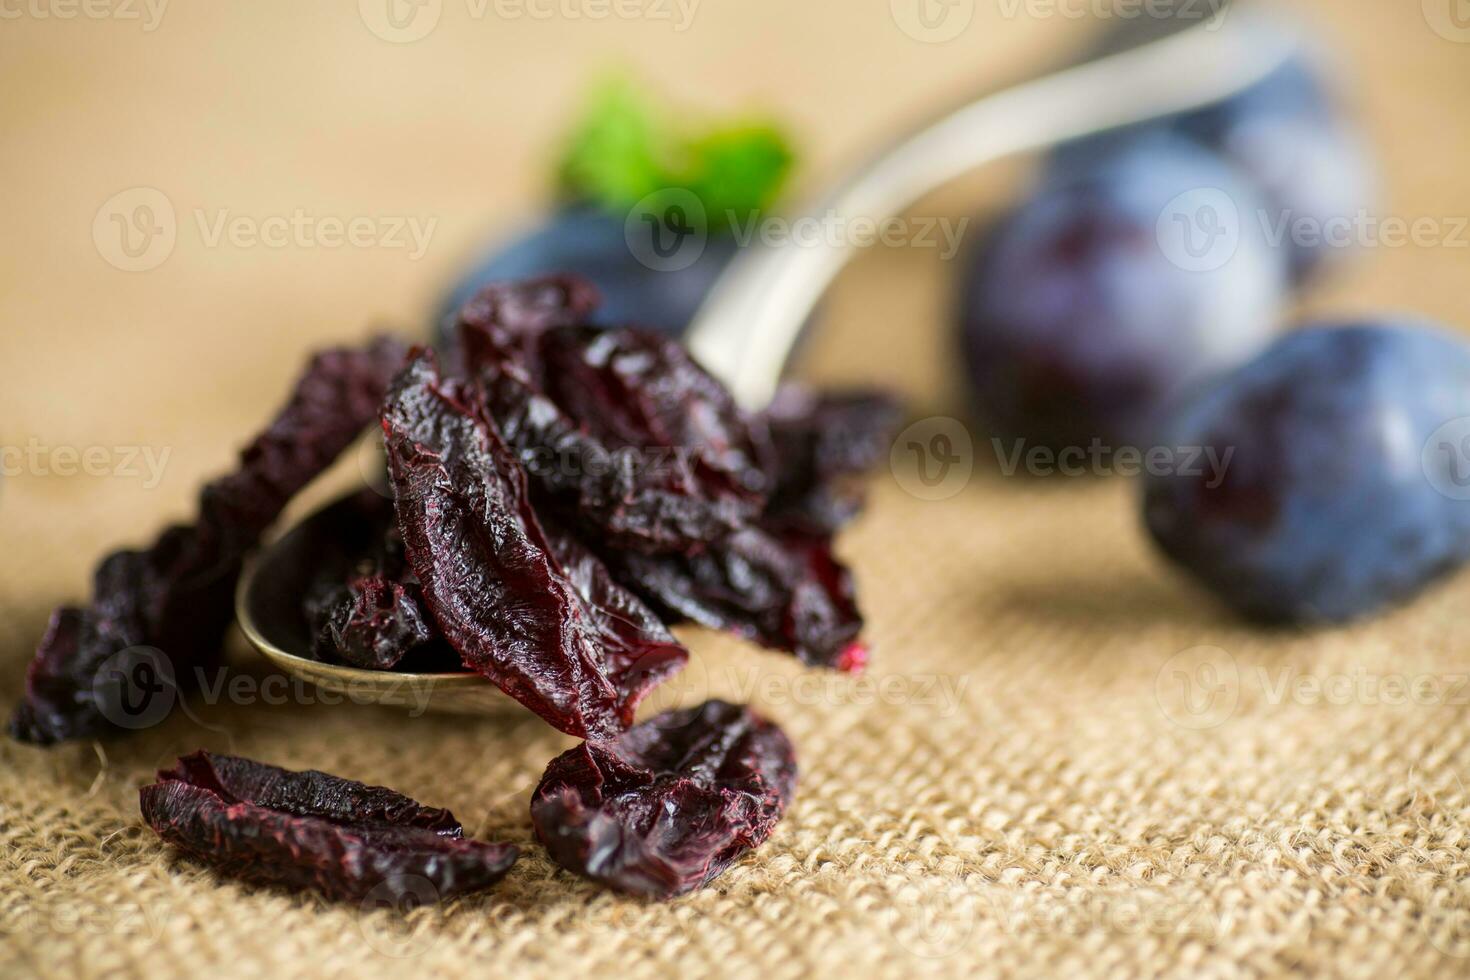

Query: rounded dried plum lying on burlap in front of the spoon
531;701;797;898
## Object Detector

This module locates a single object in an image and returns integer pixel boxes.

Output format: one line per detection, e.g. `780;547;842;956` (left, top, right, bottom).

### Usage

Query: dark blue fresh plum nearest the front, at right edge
1144;323;1470;623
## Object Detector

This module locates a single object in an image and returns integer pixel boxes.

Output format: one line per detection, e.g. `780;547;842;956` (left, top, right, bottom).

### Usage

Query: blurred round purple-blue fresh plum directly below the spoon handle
960;137;1285;450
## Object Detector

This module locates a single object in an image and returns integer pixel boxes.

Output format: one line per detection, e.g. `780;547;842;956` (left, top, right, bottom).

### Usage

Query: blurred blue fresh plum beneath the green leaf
437;206;735;345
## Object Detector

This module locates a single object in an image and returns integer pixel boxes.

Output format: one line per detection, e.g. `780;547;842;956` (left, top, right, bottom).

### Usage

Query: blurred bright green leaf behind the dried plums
559;79;795;231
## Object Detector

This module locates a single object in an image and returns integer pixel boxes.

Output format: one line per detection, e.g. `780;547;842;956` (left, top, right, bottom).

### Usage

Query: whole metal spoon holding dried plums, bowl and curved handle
235;0;1298;714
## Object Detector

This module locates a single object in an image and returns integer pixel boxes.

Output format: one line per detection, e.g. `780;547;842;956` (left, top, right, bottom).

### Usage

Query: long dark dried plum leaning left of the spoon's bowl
10;338;404;743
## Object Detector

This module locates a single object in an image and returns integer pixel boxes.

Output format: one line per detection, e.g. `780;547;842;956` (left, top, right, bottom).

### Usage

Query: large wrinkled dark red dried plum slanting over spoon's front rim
373;351;688;738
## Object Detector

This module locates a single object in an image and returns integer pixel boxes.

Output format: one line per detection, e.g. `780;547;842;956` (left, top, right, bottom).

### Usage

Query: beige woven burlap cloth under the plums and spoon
0;0;1470;977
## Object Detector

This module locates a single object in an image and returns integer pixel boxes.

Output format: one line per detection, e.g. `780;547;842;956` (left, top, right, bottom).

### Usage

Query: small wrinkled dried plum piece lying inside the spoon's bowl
313;574;435;670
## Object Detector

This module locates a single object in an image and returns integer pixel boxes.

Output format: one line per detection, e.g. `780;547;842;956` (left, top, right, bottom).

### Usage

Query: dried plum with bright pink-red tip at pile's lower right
609;527;867;673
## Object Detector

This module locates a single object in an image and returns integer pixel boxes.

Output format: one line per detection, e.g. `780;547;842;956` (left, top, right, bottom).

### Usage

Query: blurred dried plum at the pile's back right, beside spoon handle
764;383;903;535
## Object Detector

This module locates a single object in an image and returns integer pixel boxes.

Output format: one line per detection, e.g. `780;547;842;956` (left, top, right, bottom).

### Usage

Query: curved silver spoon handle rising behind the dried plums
686;7;1298;408
